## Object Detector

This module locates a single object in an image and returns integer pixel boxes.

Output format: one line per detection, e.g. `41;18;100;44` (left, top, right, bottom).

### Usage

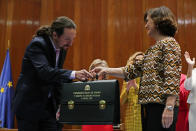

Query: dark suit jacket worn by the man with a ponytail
14;37;71;120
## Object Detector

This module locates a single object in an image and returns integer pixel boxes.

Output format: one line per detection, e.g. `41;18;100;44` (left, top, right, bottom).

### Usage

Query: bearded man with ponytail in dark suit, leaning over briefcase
14;17;92;131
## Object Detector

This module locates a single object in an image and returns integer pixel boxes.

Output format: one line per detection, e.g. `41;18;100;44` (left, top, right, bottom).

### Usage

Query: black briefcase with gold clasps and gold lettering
59;80;120;125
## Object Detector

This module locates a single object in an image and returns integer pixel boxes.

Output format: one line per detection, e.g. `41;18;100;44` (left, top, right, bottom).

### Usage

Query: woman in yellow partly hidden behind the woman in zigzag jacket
120;52;144;131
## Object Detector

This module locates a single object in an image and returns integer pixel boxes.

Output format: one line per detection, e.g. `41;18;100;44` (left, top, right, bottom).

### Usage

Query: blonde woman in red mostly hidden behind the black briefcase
82;59;113;131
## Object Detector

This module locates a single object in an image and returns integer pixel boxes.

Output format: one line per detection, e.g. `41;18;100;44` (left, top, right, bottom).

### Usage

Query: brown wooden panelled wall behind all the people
0;0;196;128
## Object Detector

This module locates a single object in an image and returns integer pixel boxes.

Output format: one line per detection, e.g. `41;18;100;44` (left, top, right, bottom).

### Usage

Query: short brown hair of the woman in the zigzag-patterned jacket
144;6;177;37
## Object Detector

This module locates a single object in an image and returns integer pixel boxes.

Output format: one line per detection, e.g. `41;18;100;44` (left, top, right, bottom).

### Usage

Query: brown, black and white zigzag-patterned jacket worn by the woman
123;37;181;106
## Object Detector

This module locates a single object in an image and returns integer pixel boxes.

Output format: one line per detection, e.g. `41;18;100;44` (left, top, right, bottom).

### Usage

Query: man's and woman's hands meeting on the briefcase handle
75;67;108;81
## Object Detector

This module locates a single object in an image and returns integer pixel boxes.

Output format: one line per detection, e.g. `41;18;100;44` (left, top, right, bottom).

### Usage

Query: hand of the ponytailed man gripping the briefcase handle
75;69;93;81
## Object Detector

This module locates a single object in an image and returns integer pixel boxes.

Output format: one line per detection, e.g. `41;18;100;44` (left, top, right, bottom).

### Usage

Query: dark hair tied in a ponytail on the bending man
35;16;77;37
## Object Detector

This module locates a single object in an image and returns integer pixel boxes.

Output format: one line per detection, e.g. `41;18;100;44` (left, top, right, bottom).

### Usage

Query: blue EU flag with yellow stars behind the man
0;50;14;128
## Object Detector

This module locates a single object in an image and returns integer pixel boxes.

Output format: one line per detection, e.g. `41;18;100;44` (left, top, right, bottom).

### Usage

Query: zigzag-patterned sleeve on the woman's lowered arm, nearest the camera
162;41;181;96
